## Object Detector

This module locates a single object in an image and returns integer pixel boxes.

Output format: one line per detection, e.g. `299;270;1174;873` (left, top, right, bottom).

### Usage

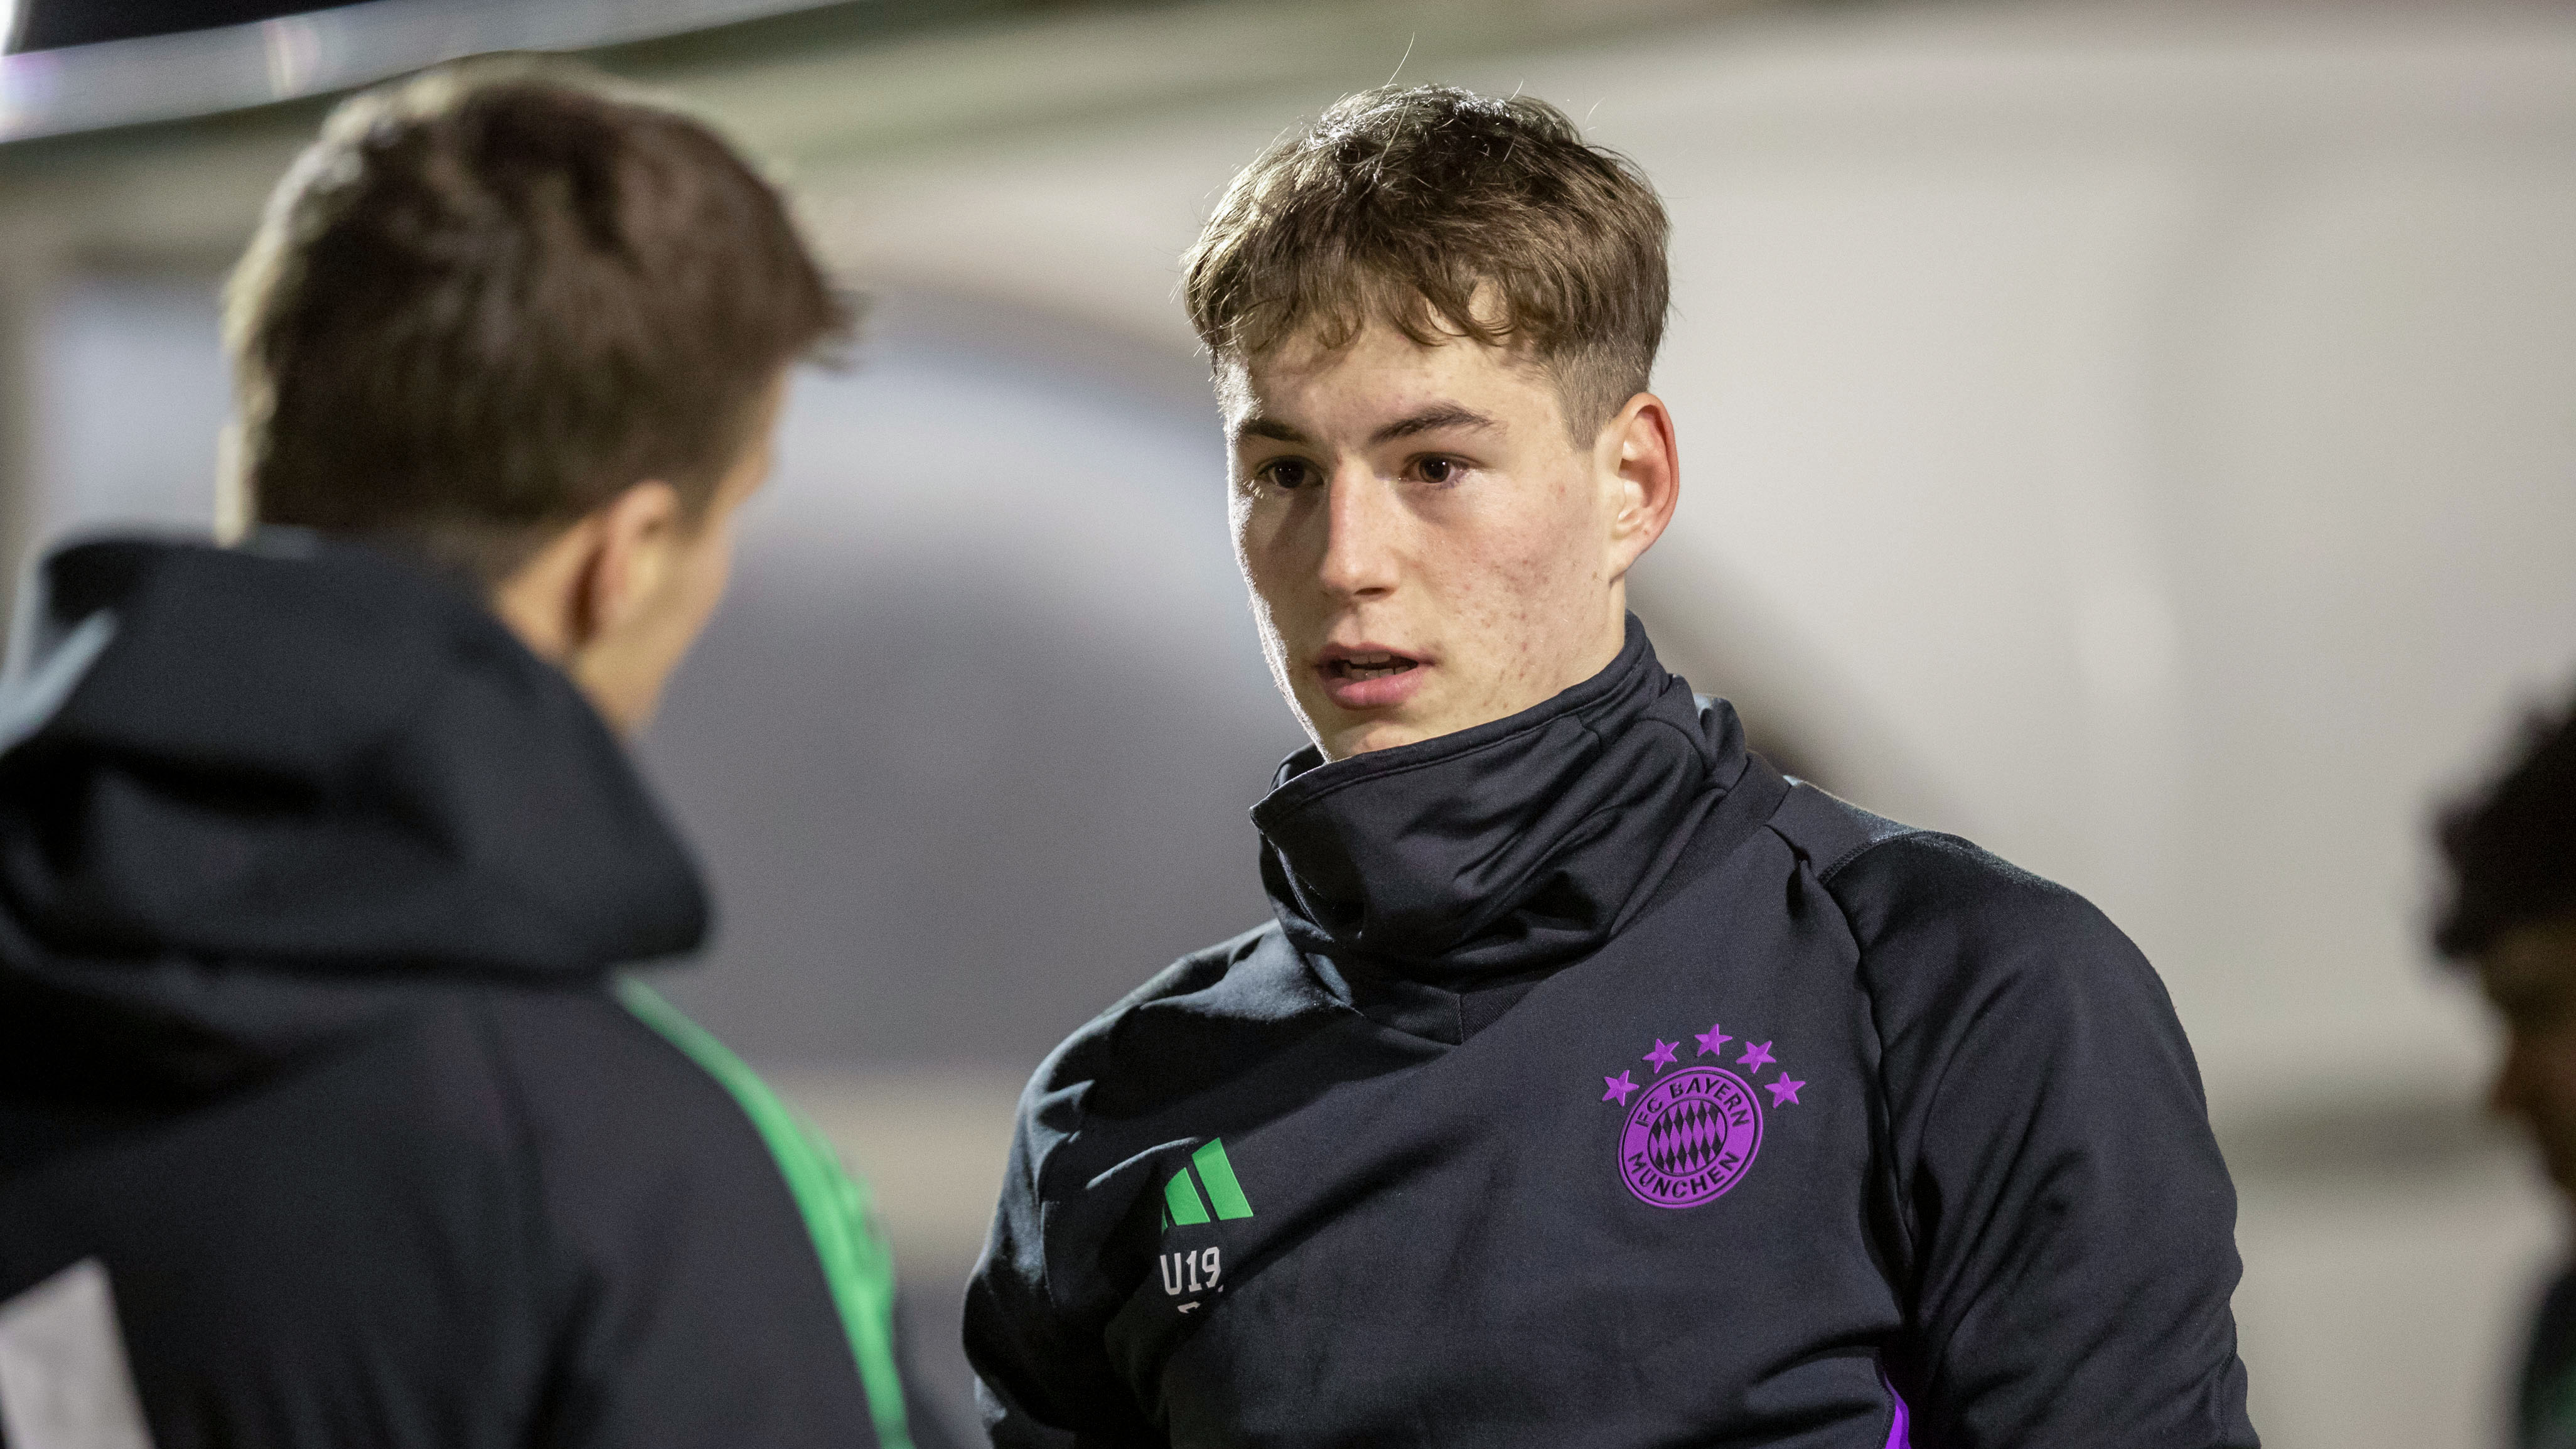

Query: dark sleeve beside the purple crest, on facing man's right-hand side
1832;836;2257;1449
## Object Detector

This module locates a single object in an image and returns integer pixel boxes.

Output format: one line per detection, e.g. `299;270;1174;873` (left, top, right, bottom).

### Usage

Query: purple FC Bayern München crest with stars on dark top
1602;1023;1806;1207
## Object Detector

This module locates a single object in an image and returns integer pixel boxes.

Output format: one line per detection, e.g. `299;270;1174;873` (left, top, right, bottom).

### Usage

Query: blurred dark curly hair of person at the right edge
2434;686;2576;959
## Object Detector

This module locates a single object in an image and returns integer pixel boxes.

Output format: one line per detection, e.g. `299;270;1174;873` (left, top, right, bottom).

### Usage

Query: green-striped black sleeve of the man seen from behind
486;993;938;1449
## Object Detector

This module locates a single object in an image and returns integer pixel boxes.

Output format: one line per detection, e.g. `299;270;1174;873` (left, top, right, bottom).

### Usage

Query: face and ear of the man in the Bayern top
1218;325;1672;758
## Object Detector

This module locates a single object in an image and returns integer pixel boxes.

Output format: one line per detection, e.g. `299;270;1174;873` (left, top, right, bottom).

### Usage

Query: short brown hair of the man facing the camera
1183;85;1672;433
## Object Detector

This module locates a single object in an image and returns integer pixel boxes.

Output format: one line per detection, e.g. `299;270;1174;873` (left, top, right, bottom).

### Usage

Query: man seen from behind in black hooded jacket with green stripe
0;67;948;1449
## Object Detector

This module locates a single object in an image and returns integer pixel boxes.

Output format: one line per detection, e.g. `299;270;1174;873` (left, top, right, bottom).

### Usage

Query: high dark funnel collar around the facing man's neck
1252;613;1744;985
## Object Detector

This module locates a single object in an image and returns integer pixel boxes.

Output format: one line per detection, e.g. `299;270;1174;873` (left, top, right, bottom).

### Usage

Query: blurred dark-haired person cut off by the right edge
2434;686;2576;1449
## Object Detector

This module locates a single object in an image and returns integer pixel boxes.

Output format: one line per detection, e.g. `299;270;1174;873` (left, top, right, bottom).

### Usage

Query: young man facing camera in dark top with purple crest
966;88;2254;1449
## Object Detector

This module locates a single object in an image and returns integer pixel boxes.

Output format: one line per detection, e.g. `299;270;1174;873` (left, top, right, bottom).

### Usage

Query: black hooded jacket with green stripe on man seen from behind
0;534;948;1449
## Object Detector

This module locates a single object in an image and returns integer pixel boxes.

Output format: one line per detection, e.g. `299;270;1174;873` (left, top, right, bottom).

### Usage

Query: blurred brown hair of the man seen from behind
224;59;850;583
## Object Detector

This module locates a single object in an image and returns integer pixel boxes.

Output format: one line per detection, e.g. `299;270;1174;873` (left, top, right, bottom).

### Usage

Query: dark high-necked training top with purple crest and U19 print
966;619;2254;1449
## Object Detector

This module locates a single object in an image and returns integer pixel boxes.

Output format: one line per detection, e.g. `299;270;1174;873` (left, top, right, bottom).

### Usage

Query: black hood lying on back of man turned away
0;531;706;1075
